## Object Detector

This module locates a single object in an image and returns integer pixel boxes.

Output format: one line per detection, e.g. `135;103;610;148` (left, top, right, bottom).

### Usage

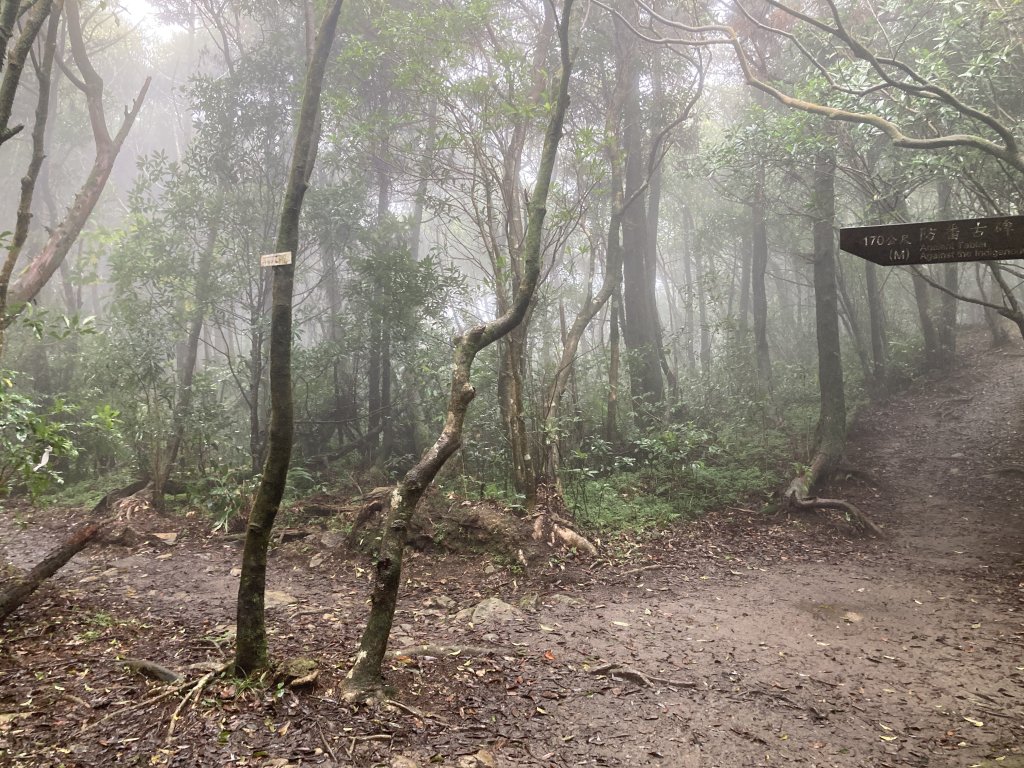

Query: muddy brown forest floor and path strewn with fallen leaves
0;337;1024;768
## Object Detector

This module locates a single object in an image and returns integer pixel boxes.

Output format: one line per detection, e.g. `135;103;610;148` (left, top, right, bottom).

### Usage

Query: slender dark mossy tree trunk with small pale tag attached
234;0;342;675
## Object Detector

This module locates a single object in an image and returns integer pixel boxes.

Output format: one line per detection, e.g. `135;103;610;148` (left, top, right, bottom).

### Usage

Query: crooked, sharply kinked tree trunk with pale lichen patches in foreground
345;0;572;700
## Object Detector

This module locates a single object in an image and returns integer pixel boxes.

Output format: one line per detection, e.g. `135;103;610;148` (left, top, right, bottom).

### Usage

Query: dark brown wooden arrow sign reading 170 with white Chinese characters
839;216;1024;266
